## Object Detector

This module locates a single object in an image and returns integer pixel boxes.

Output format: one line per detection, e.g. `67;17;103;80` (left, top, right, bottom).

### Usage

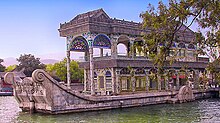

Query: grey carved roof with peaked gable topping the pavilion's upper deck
59;9;195;42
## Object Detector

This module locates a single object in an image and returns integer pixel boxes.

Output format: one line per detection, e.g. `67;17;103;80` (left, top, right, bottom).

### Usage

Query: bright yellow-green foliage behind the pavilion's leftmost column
46;59;84;81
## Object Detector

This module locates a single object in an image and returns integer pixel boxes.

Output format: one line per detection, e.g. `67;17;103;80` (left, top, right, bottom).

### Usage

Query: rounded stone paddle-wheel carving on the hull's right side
177;86;195;103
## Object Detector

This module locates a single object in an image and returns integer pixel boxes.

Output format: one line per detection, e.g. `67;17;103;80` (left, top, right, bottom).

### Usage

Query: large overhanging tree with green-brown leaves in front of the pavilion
140;0;220;72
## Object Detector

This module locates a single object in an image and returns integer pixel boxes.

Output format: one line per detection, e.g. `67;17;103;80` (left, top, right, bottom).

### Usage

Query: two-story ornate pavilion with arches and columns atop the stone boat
59;9;208;95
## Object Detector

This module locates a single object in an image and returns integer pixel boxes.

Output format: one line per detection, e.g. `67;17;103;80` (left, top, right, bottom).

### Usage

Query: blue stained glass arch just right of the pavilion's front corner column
93;34;111;49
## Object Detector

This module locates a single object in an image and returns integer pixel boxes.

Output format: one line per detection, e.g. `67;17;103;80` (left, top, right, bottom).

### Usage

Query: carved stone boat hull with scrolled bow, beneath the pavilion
6;70;217;114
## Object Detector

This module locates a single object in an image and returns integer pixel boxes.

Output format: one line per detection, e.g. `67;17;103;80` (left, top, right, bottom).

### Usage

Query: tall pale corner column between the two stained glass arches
89;47;95;95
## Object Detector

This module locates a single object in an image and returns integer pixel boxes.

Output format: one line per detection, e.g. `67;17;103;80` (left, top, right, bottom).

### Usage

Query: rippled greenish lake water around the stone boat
0;97;220;123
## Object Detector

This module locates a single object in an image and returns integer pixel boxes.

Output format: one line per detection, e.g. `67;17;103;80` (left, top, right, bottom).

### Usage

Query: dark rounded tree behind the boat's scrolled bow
17;54;46;77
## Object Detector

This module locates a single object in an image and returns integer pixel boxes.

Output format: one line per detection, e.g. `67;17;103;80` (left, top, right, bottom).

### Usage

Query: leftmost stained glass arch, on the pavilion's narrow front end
70;37;88;52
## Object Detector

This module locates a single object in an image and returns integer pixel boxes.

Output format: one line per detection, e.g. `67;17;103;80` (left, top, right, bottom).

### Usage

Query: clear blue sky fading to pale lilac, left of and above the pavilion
0;0;174;60
